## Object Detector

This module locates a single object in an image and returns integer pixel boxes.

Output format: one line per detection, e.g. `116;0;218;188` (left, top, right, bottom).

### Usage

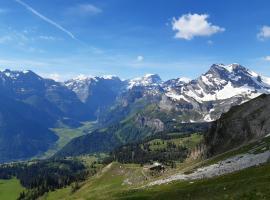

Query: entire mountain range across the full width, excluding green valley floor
0;64;270;162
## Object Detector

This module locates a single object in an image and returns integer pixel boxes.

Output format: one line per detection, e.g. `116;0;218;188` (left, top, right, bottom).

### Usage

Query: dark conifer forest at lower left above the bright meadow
0;159;89;200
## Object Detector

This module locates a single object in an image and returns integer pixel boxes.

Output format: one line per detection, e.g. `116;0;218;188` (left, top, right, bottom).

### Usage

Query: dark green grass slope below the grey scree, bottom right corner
119;164;270;200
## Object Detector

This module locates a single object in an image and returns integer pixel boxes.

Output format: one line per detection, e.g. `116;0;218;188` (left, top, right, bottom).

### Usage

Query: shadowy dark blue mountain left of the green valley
0;70;88;163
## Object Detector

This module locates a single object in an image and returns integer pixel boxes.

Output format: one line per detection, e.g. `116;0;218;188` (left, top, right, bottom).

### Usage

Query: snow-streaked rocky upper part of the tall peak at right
163;63;270;103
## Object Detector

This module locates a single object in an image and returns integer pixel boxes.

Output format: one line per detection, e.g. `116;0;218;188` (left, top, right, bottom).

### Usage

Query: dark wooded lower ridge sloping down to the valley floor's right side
55;116;209;157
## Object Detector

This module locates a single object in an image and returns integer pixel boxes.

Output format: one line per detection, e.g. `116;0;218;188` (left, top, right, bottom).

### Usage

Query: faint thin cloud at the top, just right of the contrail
67;4;102;17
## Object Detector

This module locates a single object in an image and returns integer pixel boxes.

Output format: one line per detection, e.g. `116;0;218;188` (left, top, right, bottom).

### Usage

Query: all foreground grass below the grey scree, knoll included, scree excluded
43;163;270;200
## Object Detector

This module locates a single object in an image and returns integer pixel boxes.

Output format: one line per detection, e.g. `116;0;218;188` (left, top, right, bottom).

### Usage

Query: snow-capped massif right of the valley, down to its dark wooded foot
55;64;270;156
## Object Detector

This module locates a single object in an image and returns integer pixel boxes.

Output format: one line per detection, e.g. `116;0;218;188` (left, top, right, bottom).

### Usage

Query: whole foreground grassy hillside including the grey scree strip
42;132;270;200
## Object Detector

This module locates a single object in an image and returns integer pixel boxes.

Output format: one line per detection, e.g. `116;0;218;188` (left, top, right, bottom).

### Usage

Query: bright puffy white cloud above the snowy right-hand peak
172;14;225;40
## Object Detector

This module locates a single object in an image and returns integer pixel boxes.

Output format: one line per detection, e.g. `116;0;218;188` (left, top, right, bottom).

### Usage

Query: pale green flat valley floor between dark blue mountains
41;122;94;158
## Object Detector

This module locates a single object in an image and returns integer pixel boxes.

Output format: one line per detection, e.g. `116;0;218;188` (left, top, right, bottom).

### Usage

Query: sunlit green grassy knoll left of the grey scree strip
43;163;145;200
